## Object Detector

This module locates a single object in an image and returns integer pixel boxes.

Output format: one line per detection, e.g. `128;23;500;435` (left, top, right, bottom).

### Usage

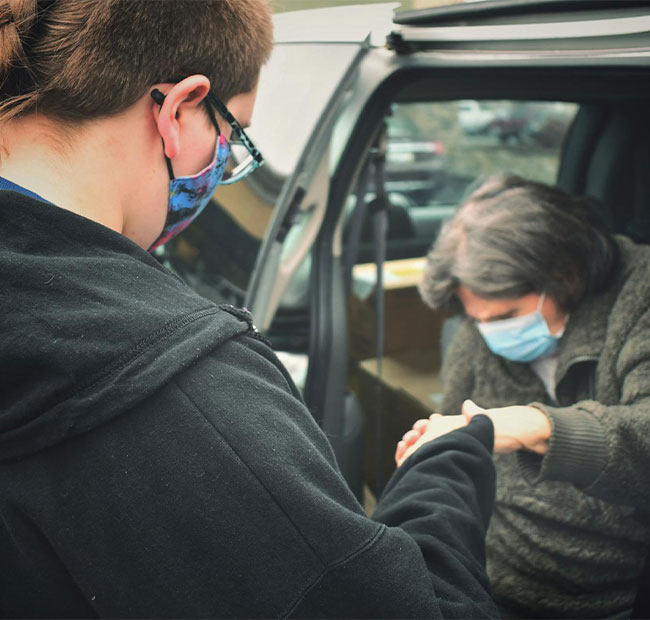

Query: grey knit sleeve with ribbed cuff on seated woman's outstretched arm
518;302;650;510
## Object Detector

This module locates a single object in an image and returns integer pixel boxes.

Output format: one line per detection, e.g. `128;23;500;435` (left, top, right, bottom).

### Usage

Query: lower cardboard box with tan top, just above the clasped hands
354;348;442;493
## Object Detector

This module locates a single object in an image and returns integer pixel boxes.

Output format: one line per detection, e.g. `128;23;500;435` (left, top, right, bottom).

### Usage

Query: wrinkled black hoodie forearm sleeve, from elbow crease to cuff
373;416;498;618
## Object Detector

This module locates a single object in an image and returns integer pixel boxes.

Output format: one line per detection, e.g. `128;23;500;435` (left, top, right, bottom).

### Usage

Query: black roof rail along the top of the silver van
393;0;650;26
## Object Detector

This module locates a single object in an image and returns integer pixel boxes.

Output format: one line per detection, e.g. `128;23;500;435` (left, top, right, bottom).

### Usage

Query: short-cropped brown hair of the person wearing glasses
0;0;273;123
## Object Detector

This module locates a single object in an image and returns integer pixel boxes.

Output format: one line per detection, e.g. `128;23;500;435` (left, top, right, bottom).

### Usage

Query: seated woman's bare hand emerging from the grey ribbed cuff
462;400;551;454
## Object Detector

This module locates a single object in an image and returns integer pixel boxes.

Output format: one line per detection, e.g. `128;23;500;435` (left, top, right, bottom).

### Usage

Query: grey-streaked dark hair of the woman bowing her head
420;174;619;312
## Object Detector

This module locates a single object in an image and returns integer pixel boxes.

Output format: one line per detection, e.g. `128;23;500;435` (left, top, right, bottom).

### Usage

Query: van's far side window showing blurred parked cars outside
387;100;577;206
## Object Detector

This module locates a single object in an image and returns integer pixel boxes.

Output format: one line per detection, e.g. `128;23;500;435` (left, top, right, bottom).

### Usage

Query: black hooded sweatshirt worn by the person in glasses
0;191;496;618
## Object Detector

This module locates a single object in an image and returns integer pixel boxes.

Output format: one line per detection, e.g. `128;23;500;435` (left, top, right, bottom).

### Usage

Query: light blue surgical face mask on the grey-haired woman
477;295;561;362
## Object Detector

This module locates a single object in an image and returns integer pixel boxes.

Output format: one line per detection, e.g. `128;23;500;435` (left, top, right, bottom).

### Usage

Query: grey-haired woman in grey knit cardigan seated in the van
397;176;650;618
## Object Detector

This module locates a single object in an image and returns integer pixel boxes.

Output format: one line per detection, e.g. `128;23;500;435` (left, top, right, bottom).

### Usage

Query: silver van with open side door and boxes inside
158;0;650;512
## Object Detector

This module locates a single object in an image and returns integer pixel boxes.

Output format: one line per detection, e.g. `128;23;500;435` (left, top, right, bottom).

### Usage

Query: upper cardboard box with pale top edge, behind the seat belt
349;258;443;360
